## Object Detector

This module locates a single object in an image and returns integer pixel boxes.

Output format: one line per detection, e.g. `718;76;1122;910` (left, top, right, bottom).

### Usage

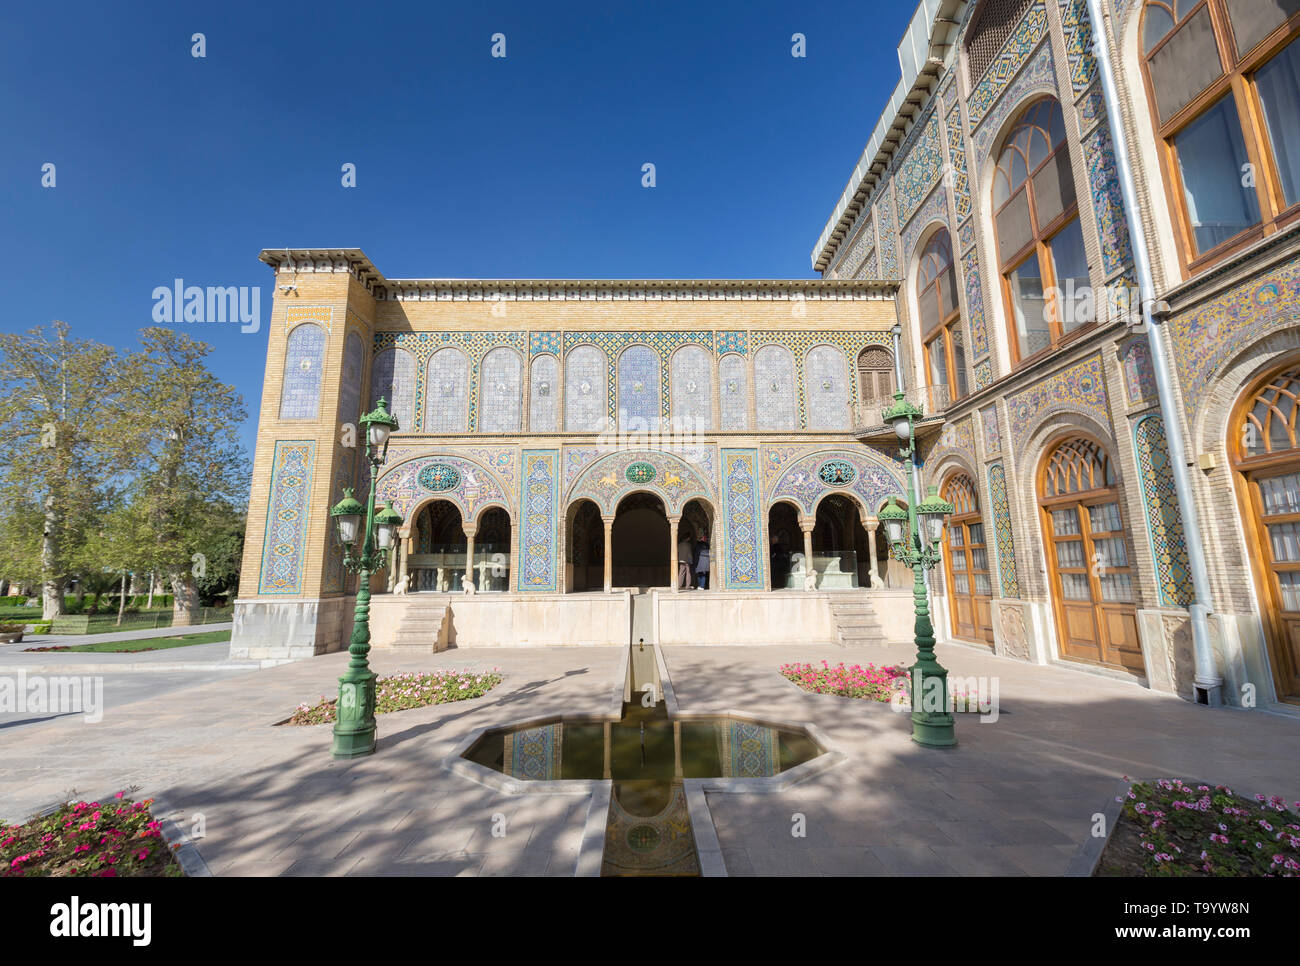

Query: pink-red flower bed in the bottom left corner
0;792;185;876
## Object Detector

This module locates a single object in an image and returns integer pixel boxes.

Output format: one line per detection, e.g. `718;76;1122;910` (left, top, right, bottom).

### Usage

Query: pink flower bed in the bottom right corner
1097;779;1300;876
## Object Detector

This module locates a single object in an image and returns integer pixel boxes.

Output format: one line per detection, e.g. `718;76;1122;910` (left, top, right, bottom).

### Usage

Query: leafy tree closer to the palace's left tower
125;326;248;627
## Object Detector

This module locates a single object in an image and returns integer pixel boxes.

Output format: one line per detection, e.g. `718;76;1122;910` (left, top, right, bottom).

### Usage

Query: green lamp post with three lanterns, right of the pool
880;390;957;748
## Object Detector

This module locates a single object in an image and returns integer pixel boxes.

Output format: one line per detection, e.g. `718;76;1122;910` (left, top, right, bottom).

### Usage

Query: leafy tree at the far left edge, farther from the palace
0;322;126;619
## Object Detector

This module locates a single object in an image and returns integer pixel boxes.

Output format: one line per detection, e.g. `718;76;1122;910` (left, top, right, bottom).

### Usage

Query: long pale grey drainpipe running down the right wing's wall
1087;0;1223;707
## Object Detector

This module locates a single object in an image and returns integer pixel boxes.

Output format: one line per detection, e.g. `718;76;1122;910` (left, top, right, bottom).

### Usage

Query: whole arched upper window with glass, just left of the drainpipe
993;98;1096;361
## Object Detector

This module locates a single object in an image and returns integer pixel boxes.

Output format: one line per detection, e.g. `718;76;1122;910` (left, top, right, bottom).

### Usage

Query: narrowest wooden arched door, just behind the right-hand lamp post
941;473;993;644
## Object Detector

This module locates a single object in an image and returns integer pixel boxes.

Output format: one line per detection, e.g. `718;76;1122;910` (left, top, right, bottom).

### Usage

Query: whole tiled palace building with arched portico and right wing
233;0;1300;711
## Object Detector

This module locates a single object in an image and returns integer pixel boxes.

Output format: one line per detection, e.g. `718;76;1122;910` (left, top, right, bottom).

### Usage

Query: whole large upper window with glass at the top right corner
1141;0;1300;270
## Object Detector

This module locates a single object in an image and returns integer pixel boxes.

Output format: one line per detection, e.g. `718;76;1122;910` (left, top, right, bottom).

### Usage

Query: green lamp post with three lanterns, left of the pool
329;399;402;758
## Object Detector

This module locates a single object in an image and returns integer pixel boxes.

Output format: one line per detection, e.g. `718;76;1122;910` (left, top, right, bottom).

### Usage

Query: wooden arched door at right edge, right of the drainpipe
1229;361;1300;703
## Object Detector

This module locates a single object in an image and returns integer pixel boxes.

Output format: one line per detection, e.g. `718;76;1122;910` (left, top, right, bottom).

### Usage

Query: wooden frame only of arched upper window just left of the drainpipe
991;94;1097;368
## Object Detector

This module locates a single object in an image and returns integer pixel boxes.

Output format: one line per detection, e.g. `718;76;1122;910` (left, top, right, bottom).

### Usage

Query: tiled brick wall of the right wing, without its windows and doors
814;0;1300;707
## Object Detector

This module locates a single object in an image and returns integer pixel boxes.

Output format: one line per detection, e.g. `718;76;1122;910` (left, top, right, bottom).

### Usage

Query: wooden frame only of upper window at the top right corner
1138;0;1300;278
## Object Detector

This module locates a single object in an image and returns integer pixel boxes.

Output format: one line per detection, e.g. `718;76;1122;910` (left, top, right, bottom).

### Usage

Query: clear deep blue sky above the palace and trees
0;0;914;454
